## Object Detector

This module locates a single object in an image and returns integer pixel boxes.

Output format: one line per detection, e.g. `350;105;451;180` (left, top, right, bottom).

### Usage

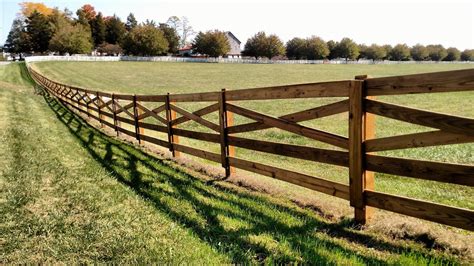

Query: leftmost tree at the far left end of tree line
4;18;31;54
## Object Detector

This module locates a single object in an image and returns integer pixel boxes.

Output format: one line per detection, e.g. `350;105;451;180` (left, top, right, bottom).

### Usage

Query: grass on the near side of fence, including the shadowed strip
0;62;470;265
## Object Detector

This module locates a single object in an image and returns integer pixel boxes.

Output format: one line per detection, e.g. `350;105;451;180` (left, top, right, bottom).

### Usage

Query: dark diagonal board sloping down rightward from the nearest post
365;100;474;135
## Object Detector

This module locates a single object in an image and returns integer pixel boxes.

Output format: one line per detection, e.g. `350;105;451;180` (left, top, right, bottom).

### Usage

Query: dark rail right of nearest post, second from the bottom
366;154;474;186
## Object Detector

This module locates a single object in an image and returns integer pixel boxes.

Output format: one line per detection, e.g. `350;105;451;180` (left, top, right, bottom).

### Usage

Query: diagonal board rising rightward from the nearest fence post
365;130;474;152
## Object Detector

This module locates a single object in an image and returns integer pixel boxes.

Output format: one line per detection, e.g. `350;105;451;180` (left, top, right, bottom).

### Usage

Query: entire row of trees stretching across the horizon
5;2;474;61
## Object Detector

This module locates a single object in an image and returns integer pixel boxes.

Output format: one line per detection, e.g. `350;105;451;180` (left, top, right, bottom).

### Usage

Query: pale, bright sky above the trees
0;0;474;49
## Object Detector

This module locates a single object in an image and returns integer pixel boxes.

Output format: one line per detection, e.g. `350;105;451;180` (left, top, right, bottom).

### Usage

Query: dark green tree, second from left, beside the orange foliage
26;11;52;53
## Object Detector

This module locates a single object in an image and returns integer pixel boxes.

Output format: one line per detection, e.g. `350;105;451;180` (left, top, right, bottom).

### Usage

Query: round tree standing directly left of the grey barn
193;30;230;57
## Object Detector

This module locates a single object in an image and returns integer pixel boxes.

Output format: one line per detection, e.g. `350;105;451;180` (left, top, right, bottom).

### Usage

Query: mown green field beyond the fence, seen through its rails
35;59;474;209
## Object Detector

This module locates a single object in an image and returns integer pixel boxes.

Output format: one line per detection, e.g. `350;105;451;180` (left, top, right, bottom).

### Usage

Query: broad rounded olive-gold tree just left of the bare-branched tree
122;25;168;56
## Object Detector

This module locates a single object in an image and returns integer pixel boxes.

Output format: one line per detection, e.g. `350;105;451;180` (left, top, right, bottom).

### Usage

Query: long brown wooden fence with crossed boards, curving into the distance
29;67;474;231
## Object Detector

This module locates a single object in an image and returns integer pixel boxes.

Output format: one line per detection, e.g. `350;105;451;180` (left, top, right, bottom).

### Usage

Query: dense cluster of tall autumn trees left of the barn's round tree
4;2;194;56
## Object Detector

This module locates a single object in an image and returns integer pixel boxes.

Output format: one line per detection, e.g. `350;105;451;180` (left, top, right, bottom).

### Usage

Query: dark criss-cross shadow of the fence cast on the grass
43;89;448;264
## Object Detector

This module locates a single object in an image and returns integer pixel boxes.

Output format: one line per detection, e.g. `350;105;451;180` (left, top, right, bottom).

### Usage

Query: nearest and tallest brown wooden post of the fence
349;76;374;224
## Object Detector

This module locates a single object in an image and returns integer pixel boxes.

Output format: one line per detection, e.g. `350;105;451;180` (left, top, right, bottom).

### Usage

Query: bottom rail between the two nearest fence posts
229;157;349;200
